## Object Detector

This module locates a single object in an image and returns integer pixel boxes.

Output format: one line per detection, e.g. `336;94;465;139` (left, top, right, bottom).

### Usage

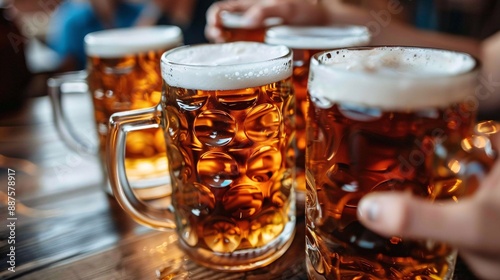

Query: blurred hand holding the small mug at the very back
205;0;327;43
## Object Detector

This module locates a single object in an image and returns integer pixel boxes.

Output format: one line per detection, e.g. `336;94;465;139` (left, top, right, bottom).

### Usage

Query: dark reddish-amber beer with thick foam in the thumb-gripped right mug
306;47;477;279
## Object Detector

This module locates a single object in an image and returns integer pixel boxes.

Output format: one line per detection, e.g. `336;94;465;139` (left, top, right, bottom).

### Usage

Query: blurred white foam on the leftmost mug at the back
84;25;183;58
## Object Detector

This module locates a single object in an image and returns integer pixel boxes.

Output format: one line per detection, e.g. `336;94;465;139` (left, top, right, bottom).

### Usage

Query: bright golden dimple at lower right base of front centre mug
248;208;285;247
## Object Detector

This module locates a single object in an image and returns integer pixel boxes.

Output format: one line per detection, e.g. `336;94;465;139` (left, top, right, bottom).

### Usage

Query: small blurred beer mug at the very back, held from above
220;11;283;42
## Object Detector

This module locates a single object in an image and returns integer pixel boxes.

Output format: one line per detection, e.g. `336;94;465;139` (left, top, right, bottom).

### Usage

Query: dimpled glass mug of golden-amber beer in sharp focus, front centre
107;42;296;271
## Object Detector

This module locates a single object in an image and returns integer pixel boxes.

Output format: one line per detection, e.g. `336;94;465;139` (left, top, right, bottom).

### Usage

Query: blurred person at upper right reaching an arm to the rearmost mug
205;0;500;120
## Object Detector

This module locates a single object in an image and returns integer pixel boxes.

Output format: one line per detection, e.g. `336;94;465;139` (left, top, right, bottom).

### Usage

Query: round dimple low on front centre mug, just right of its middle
222;185;264;219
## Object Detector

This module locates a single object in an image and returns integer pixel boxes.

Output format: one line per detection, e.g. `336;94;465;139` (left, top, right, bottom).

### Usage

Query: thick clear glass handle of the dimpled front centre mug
106;105;175;230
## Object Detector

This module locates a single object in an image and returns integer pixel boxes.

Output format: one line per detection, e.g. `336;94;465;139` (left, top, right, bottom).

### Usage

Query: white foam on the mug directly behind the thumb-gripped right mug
265;25;370;50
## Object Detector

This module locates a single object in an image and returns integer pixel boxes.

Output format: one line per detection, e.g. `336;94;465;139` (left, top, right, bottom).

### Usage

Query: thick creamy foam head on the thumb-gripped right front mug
308;47;478;111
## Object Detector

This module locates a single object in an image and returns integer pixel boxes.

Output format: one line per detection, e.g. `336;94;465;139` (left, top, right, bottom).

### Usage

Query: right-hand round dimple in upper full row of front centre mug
244;103;282;142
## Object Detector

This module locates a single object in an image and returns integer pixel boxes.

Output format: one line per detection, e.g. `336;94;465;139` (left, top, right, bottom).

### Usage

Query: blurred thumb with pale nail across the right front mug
358;193;482;248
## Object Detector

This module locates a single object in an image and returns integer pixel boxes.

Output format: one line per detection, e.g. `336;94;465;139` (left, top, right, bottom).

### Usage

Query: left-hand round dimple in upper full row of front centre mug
194;110;236;147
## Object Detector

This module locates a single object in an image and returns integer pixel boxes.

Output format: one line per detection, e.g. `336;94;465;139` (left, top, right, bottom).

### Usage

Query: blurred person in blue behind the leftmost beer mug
47;0;215;71
